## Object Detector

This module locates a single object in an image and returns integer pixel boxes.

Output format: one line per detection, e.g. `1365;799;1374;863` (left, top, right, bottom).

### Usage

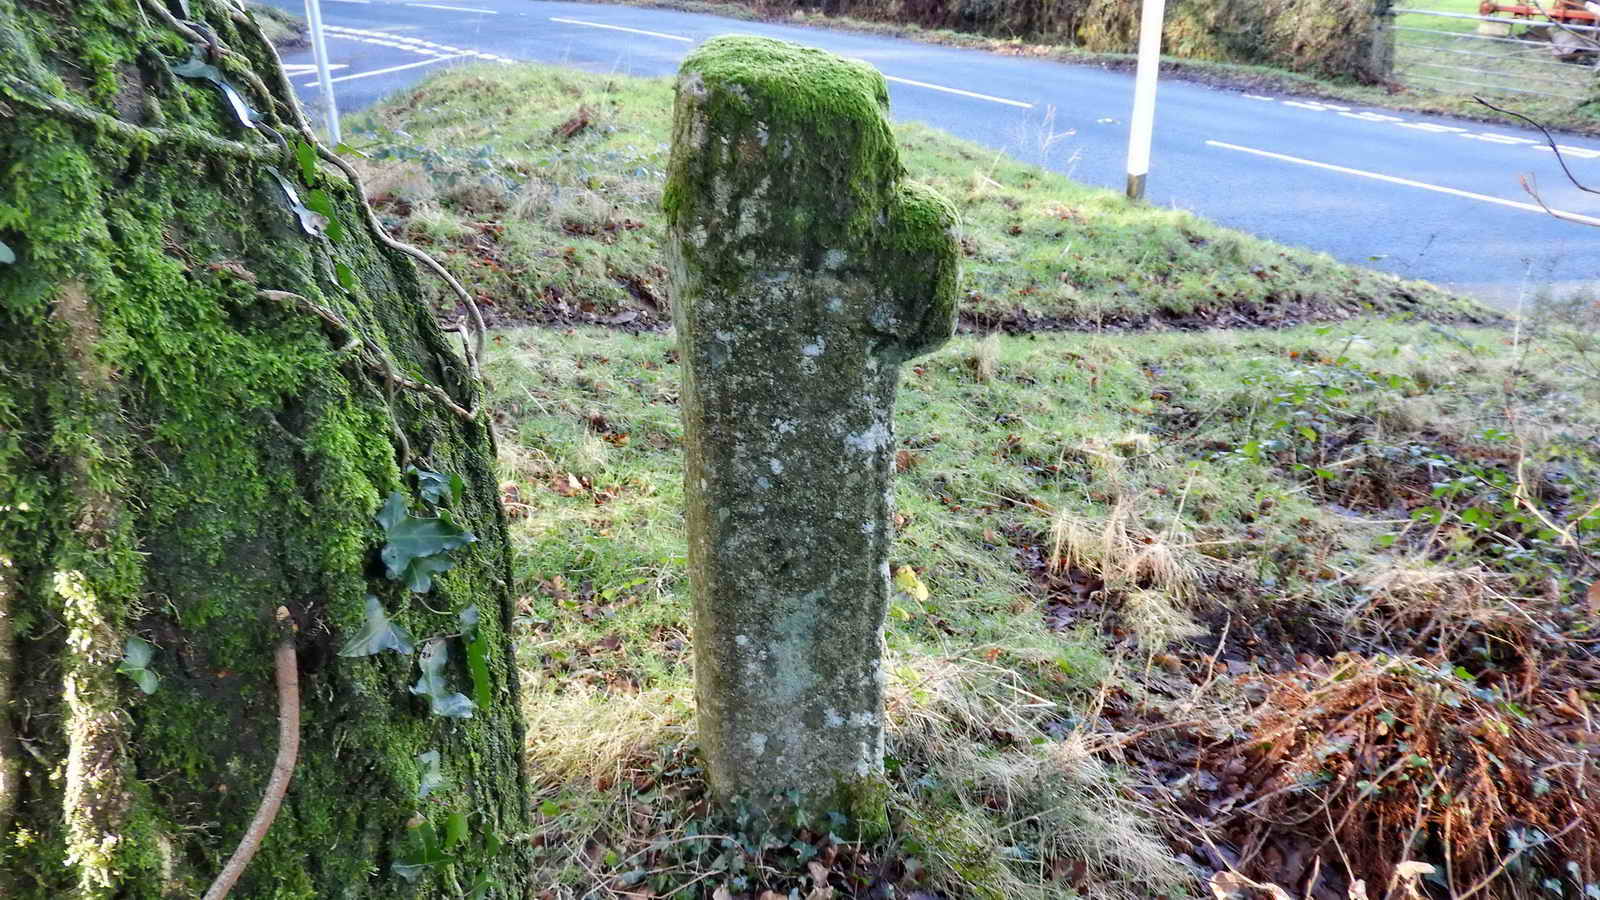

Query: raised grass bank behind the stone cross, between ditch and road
349;66;1483;328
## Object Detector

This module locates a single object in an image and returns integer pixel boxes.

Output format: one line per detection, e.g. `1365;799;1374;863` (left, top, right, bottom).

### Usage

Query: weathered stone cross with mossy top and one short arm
662;37;958;830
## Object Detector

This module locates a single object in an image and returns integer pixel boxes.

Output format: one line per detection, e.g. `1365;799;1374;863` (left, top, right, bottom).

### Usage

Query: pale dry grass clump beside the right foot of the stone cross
888;657;1189;900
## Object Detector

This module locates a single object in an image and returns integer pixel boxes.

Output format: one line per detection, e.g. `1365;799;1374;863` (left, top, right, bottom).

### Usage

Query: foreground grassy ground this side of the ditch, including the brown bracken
486;312;1600;898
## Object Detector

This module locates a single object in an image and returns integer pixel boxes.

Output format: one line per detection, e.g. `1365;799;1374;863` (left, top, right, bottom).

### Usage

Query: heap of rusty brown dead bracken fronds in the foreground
1203;655;1600;897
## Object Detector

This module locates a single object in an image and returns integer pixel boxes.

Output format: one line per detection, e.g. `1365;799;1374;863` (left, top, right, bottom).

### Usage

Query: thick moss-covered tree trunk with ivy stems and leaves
0;0;528;898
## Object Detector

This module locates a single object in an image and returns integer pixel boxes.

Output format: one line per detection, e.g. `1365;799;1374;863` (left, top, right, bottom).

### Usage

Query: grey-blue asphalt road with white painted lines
256;0;1600;306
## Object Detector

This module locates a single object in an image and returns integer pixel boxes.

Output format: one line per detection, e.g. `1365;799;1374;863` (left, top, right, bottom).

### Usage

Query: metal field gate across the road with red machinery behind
1387;8;1600;104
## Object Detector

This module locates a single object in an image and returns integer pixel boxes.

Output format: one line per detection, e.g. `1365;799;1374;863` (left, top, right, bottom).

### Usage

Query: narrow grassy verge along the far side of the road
582;0;1600;135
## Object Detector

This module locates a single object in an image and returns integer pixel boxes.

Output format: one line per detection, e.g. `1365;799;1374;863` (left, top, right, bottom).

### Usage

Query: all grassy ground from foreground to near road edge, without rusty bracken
352;67;1600;900
